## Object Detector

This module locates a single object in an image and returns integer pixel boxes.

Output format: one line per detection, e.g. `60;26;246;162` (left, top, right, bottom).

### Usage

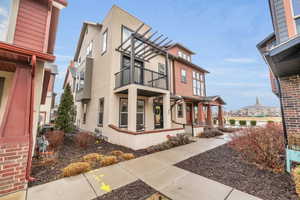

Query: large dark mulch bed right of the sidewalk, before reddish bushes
176;145;298;200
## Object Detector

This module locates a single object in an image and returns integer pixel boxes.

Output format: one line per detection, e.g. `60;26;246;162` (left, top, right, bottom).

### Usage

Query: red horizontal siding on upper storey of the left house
14;0;48;52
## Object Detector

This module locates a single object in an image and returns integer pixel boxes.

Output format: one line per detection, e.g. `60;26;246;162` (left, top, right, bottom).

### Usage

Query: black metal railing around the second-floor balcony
115;66;168;90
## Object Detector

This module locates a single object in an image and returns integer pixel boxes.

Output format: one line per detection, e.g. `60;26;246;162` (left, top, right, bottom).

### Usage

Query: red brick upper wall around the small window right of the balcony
174;60;202;97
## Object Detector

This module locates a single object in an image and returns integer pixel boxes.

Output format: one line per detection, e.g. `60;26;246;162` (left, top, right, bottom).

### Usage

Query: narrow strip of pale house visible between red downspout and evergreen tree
39;65;58;126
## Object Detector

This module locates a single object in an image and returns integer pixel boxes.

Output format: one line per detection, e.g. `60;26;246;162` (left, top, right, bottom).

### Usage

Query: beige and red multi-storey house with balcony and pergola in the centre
71;6;224;149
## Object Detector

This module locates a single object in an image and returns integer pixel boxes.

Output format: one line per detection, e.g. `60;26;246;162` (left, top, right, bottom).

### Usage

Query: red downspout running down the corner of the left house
26;55;36;182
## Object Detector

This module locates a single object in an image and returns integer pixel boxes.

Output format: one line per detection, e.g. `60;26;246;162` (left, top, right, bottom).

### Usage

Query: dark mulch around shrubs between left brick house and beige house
29;135;148;187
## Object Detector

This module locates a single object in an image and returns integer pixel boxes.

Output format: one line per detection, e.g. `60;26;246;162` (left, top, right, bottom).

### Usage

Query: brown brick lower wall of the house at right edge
280;75;300;134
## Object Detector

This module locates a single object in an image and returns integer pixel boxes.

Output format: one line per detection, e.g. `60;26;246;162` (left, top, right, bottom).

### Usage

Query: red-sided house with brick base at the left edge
0;0;67;199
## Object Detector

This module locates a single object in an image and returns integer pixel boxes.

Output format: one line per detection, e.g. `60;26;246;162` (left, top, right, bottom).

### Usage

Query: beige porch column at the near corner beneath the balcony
128;85;137;132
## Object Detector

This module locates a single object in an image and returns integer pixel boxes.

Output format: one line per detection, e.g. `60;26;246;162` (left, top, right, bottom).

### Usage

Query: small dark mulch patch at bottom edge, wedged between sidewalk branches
94;180;170;200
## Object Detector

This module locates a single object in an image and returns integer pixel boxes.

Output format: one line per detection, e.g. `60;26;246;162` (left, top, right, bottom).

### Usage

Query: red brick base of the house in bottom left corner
0;143;28;196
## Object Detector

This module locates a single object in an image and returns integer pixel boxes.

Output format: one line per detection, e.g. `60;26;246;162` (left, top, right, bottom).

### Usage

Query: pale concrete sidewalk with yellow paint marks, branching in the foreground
27;139;259;200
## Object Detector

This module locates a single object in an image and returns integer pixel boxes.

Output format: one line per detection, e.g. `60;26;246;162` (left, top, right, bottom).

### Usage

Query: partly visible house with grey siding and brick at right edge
257;0;300;142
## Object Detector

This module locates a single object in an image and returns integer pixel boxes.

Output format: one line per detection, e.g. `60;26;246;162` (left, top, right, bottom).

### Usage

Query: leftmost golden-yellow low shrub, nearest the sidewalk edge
63;162;91;177
